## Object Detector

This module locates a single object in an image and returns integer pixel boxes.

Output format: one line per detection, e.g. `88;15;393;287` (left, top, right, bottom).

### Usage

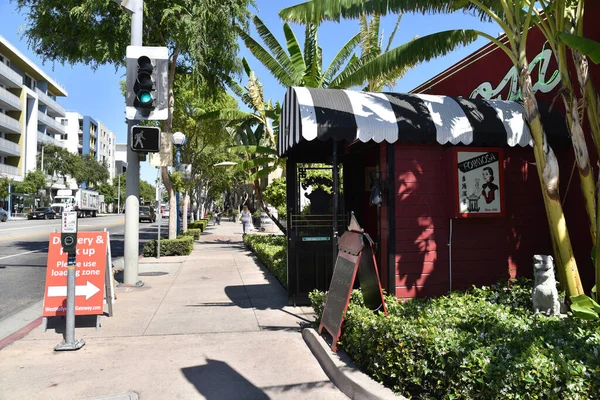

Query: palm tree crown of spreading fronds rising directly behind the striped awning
238;13;477;89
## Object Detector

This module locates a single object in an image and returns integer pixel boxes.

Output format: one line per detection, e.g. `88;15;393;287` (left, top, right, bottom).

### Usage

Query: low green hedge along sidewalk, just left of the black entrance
244;234;287;288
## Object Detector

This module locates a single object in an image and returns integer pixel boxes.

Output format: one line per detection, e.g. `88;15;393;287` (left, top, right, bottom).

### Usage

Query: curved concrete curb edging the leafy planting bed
302;328;408;400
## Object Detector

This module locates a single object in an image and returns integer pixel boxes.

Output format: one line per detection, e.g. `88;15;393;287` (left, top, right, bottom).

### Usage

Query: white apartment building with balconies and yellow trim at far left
0;35;67;184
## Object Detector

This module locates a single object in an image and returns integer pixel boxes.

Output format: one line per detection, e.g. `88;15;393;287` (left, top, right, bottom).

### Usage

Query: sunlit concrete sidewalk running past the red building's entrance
0;221;346;400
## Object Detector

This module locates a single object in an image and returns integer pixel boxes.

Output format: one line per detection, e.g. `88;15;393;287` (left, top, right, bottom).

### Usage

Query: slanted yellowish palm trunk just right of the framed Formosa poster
517;59;583;296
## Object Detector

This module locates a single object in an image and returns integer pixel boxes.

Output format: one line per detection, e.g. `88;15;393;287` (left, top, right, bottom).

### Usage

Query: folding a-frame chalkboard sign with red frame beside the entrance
319;213;387;351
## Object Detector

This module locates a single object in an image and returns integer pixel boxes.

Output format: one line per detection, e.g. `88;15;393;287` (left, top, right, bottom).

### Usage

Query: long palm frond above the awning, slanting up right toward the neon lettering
330;29;479;88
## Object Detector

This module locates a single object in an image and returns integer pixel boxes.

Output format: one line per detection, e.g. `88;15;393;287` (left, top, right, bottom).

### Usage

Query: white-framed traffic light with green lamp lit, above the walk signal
126;46;169;120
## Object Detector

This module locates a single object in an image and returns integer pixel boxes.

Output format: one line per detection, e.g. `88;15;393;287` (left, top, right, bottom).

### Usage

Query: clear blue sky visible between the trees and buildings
0;0;499;183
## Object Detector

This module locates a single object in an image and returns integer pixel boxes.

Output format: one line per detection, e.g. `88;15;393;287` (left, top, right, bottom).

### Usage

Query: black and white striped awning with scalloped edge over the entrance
278;87;564;156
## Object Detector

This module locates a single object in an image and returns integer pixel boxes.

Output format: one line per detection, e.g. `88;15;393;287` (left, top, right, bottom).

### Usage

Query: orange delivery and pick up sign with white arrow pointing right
42;232;109;317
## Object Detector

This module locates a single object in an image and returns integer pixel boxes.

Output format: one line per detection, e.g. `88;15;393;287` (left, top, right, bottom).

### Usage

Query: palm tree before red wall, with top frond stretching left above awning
280;0;583;296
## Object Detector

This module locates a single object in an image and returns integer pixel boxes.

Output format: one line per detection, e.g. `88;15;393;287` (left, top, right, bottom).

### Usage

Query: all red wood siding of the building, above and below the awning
394;2;600;297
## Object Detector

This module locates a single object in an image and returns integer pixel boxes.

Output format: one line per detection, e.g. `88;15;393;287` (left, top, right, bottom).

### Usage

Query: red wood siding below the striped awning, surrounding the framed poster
390;144;589;297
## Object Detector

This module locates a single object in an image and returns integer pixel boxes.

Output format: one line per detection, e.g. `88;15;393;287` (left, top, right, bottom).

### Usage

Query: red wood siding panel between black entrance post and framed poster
394;143;449;297
